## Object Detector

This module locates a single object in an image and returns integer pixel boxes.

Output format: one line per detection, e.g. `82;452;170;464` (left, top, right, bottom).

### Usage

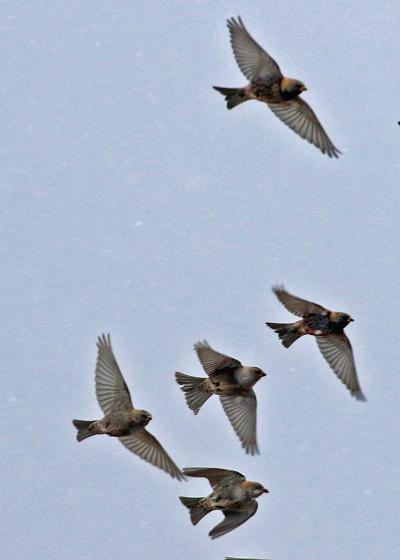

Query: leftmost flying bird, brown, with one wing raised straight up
72;334;185;480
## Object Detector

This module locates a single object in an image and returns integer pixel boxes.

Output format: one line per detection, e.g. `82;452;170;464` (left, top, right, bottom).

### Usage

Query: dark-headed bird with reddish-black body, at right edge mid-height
266;286;366;401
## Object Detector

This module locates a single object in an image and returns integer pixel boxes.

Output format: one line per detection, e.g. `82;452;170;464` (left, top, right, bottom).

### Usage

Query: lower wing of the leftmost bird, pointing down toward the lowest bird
118;429;185;480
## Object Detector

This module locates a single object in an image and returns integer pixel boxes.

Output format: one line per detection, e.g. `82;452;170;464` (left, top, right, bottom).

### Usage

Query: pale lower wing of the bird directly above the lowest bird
220;389;259;455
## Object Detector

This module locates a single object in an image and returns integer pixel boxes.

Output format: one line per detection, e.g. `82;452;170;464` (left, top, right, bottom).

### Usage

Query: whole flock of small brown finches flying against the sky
73;17;366;560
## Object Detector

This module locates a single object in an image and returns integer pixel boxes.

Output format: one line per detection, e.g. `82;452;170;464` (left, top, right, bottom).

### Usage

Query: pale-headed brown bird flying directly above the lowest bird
175;341;266;455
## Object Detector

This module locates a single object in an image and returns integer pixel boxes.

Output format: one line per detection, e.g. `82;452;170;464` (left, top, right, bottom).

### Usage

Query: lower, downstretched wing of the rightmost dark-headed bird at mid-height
315;333;366;401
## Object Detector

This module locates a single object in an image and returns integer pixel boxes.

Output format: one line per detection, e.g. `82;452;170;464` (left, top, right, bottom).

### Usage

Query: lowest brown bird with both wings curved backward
179;468;268;539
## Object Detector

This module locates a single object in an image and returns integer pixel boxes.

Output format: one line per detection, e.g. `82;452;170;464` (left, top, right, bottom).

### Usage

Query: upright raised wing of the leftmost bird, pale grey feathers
95;334;133;414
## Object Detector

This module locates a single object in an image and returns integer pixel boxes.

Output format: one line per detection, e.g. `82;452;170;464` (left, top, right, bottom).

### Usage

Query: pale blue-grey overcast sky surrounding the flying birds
0;0;400;560
